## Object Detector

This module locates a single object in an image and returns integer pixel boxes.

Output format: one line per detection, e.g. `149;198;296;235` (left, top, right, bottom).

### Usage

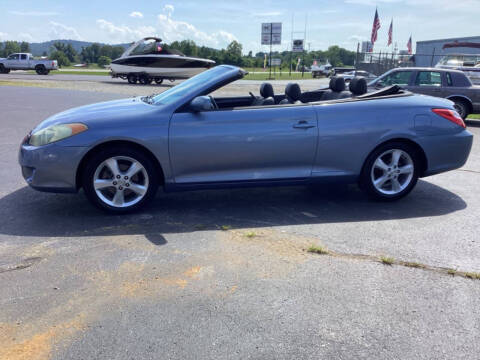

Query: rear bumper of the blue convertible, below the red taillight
420;130;473;176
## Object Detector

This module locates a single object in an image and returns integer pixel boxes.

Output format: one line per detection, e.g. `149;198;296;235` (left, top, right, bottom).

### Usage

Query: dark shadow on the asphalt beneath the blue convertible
0;180;467;245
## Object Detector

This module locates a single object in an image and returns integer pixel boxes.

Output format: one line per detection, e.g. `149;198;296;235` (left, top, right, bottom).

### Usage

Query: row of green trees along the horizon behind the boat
0;40;356;69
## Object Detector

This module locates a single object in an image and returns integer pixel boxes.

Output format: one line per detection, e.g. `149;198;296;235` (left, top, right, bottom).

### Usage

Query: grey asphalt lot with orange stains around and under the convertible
0;85;480;360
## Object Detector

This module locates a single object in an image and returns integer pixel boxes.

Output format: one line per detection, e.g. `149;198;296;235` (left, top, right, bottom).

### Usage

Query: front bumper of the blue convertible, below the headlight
18;144;87;193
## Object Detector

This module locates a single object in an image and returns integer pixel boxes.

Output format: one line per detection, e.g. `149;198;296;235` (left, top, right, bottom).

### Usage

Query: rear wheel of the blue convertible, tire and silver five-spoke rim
359;141;420;201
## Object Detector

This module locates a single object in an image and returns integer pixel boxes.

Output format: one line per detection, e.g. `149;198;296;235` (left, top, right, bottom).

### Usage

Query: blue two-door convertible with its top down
19;65;472;212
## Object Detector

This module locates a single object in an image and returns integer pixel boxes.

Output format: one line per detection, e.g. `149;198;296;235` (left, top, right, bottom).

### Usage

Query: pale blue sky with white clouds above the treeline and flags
0;0;480;53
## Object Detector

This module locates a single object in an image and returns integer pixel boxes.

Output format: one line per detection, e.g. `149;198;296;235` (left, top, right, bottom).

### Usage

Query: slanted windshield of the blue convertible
147;66;232;105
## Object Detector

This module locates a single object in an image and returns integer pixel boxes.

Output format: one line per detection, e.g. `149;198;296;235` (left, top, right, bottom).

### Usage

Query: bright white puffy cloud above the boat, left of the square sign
158;5;237;48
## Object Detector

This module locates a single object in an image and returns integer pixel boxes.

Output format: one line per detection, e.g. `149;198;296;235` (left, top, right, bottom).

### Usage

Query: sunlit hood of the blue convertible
34;97;162;131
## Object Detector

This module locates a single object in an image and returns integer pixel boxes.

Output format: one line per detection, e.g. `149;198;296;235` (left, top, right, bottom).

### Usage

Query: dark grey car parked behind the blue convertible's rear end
368;68;480;119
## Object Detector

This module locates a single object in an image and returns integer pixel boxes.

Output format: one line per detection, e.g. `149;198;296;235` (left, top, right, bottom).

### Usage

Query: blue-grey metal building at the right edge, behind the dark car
415;36;480;66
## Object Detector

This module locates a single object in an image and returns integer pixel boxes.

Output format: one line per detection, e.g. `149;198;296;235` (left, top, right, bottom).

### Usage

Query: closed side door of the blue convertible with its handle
169;105;318;184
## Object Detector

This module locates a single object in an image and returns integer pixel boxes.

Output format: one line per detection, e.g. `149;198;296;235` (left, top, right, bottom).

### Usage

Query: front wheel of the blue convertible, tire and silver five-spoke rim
82;146;159;214
